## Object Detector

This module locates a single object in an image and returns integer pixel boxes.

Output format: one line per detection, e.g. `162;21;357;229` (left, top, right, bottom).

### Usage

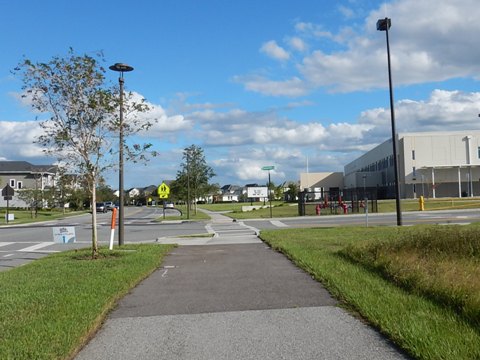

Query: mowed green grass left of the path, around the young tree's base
0;245;171;360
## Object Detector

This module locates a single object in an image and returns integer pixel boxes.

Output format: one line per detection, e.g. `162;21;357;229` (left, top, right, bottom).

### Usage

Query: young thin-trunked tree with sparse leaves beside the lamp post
15;49;154;258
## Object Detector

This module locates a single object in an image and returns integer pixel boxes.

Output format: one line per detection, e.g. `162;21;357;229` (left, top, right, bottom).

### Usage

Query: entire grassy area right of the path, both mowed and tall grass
261;225;480;360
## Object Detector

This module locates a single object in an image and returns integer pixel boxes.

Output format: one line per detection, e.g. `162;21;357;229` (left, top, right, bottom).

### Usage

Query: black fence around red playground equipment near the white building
298;189;378;216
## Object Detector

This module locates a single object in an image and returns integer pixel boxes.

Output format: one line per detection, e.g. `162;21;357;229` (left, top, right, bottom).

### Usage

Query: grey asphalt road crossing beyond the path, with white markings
0;207;480;271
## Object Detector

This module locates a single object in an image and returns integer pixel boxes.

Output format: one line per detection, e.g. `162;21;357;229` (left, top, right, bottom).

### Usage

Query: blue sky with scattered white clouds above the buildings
0;0;480;188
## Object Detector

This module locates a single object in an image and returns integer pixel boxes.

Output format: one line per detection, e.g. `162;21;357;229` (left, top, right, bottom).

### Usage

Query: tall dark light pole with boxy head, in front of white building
377;18;402;226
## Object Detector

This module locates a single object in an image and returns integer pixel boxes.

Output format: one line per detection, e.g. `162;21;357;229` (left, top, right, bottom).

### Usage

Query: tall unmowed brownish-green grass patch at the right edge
342;226;480;329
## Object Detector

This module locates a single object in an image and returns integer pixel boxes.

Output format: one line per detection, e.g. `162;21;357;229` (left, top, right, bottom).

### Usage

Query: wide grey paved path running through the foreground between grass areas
77;215;407;360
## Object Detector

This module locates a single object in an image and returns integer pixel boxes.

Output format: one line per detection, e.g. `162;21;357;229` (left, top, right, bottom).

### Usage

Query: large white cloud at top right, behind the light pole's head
242;0;480;96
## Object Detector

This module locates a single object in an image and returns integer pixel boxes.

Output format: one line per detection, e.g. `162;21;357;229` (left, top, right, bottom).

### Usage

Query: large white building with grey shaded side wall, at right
344;131;480;198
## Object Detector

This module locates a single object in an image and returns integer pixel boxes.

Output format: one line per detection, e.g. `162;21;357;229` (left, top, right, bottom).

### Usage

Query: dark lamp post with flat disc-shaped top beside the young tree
109;63;133;246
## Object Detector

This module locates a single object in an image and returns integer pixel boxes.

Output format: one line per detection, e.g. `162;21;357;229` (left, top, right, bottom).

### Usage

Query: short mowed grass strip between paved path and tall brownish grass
261;226;480;360
